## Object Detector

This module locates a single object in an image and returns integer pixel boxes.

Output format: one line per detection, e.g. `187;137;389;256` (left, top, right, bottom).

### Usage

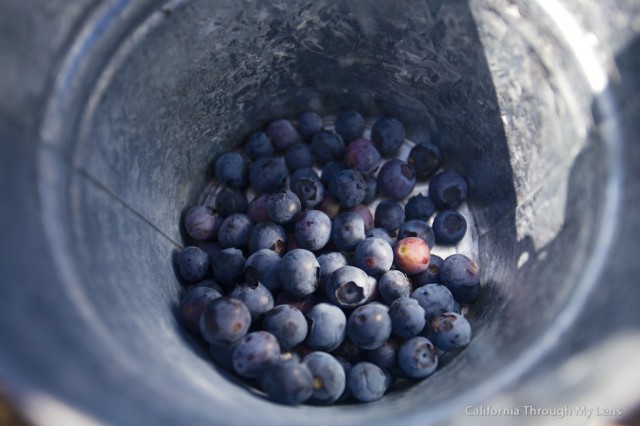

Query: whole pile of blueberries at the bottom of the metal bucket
177;110;481;405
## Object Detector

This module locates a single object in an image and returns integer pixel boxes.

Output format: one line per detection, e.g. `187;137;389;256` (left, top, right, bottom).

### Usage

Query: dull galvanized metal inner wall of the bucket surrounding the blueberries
0;0;632;425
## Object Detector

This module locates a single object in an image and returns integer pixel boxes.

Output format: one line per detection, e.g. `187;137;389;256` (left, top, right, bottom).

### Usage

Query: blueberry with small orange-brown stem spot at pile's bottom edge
302;351;347;404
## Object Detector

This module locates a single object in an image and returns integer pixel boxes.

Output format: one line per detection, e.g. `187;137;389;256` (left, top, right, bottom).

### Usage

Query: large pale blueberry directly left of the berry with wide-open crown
278;249;320;298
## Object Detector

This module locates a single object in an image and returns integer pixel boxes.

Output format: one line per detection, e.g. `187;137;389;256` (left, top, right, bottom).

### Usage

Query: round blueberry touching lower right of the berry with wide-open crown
347;303;391;350
